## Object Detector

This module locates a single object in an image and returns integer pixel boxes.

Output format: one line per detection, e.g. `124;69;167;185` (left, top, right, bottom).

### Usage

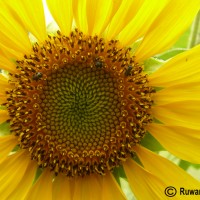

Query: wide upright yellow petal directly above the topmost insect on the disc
87;0;113;35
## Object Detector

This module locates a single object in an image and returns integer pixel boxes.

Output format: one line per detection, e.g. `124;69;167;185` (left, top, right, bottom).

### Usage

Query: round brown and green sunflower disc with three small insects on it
6;30;153;177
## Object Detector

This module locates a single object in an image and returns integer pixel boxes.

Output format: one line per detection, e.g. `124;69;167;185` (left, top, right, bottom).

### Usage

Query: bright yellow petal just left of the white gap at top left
6;0;46;42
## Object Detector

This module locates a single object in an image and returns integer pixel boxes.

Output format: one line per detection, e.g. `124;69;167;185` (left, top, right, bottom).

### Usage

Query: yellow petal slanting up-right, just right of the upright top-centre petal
106;0;144;42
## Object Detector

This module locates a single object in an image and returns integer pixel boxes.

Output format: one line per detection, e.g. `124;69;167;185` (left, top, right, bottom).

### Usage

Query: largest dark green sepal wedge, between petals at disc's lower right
141;133;165;152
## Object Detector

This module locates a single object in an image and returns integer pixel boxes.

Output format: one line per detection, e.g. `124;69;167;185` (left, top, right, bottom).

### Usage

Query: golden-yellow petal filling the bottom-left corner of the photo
0;150;30;199
